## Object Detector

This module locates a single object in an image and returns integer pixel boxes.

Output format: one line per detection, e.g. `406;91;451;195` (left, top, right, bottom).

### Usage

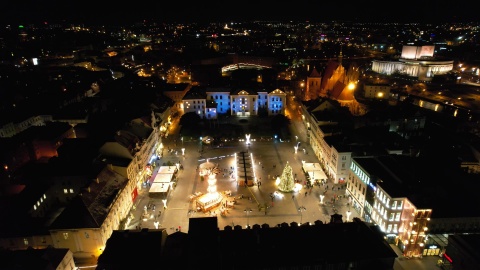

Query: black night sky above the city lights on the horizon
0;0;478;23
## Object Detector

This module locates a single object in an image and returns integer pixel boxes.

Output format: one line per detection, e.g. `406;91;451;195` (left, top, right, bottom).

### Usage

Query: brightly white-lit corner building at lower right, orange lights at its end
346;156;432;257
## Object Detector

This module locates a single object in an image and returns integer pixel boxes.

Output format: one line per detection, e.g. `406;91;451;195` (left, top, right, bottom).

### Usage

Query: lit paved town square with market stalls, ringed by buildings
125;114;359;233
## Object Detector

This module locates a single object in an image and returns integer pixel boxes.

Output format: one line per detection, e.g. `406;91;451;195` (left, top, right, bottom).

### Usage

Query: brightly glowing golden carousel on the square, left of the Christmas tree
196;160;224;212
